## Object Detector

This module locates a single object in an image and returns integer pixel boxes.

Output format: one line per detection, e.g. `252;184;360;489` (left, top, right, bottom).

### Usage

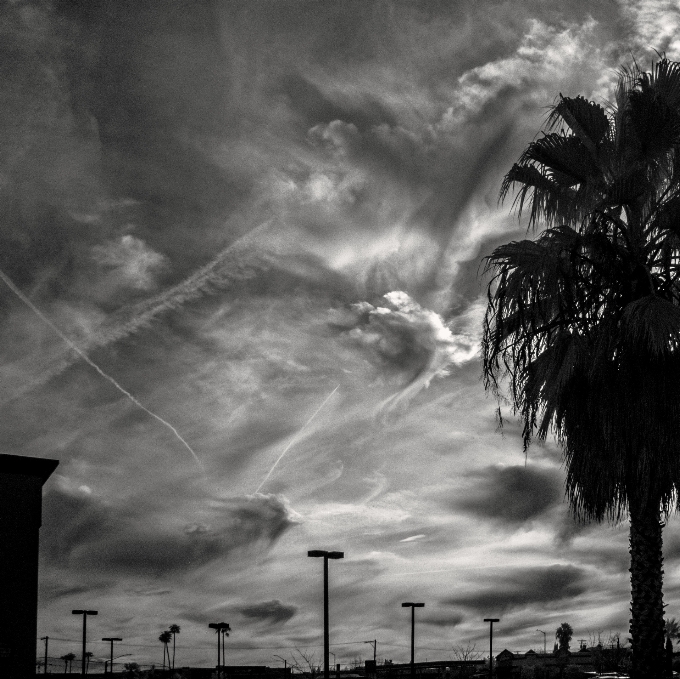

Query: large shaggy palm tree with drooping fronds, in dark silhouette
483;57;680;679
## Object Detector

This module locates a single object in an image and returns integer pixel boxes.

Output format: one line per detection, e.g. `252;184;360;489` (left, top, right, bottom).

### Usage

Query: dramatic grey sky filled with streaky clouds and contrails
0;0;680;666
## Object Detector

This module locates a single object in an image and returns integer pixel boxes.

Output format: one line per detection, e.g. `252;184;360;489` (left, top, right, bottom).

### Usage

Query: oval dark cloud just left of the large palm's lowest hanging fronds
452;466;564;526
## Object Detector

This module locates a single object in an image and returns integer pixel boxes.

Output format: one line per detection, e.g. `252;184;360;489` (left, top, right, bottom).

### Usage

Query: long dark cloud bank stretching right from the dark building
41;488;295;575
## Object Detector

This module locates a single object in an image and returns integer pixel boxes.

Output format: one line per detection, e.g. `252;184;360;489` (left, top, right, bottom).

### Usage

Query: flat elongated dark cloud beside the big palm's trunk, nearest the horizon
442;565;591;613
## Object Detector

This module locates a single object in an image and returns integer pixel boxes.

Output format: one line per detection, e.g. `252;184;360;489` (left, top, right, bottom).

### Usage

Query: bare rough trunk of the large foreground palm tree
630;503;664;679
